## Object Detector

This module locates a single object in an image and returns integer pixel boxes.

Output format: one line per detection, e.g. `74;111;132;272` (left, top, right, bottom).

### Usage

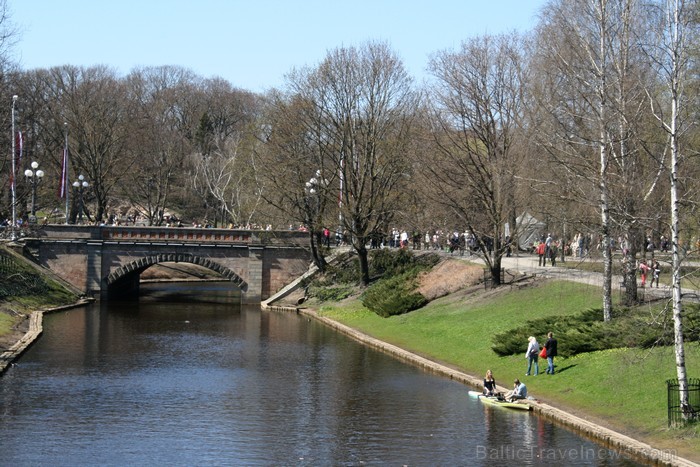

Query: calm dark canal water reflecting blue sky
0;284;638;466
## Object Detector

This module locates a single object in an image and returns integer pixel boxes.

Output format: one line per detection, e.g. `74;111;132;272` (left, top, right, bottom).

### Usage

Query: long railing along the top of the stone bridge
33;224;309;246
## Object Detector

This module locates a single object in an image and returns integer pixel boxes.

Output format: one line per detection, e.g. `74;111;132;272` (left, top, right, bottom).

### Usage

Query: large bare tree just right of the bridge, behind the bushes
280;43;417;284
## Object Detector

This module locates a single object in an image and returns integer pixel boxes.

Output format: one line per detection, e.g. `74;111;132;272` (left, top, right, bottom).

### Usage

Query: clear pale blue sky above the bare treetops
8;0;545;92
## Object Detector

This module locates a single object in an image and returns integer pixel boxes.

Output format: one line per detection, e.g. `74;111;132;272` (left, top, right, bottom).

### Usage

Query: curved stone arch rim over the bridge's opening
106;253;248;292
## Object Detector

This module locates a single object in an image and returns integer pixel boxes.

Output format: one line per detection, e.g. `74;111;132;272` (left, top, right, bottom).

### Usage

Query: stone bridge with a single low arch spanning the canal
24;225;311;303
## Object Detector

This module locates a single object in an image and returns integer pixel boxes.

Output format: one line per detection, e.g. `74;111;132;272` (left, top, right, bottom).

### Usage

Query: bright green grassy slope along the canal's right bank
309;282;700;462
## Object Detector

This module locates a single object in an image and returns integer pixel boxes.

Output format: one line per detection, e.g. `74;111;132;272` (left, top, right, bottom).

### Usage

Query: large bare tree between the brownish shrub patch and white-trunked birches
424;35;525;285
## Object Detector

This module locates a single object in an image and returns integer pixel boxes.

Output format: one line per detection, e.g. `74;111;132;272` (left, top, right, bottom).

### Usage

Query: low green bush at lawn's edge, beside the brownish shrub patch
362;271;428;318
